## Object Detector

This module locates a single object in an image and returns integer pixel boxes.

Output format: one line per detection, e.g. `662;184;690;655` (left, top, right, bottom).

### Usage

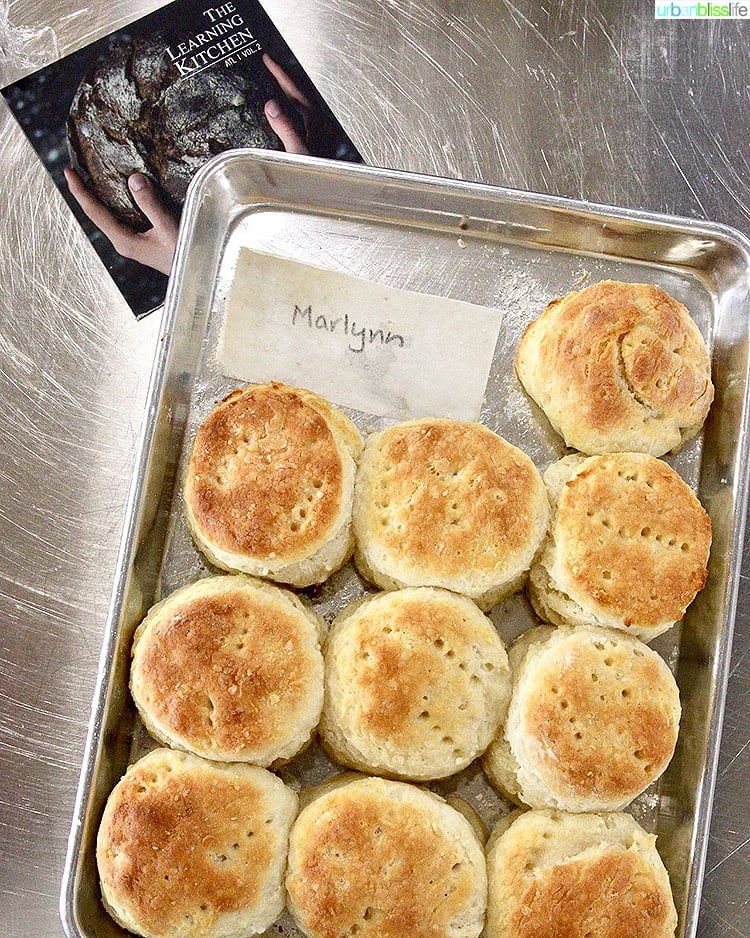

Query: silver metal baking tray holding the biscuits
61;150;750;938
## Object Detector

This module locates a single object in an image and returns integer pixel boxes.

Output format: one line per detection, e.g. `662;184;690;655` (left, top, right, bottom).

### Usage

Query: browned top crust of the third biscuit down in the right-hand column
512;627;680;804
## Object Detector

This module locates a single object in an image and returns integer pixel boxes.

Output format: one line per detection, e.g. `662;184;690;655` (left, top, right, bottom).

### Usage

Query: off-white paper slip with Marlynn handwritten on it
218;248;502;420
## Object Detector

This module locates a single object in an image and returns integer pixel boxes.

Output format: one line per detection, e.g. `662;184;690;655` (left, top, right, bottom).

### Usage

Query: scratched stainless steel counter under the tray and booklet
0;0;750;938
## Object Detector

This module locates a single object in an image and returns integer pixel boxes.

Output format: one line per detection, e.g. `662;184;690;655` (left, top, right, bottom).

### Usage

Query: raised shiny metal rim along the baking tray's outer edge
59;148;750;938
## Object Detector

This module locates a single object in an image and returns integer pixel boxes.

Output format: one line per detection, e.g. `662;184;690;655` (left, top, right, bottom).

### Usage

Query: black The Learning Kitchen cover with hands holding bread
2;0;361;316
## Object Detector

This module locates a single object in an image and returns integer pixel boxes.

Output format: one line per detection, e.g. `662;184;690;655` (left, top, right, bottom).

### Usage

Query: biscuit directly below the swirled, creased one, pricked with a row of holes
529;453;711;641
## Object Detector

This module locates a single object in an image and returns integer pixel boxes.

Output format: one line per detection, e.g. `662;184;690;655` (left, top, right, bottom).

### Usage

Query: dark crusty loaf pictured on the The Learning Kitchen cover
67;38;283;231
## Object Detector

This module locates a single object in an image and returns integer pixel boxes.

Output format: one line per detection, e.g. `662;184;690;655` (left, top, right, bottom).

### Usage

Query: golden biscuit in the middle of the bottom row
286;778;487;938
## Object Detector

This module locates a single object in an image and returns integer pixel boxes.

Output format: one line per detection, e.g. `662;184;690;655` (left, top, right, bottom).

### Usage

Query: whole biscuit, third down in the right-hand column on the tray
483;626;680;812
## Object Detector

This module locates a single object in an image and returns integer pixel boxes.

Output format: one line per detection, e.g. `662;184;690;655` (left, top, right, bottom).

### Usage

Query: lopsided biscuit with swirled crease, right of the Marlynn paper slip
516;280;714;456
